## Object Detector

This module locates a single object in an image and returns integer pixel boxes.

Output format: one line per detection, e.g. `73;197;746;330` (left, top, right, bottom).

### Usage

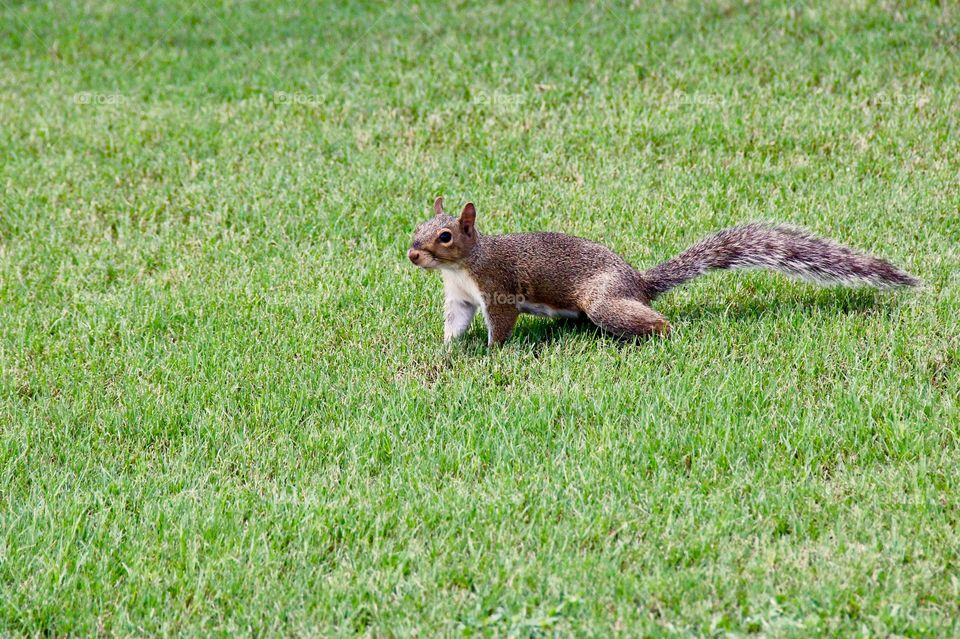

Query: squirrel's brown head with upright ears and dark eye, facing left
407;197;477;268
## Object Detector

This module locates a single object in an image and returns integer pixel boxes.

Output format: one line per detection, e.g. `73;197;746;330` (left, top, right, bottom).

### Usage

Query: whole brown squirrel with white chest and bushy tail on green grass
407;197;920;346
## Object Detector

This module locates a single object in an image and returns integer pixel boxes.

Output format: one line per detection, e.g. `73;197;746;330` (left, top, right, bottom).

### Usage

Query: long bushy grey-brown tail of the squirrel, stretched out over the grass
642;223;920;299
